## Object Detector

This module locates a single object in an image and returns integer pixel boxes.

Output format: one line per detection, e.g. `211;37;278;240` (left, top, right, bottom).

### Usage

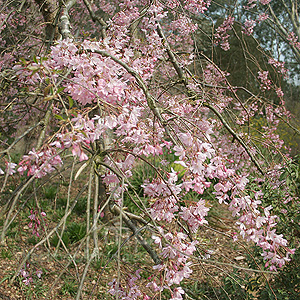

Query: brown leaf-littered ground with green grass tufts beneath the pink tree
0;175;278;300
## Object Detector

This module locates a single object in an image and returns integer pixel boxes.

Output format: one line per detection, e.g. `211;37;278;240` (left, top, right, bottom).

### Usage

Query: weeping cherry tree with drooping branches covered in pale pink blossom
0;0;299;299
